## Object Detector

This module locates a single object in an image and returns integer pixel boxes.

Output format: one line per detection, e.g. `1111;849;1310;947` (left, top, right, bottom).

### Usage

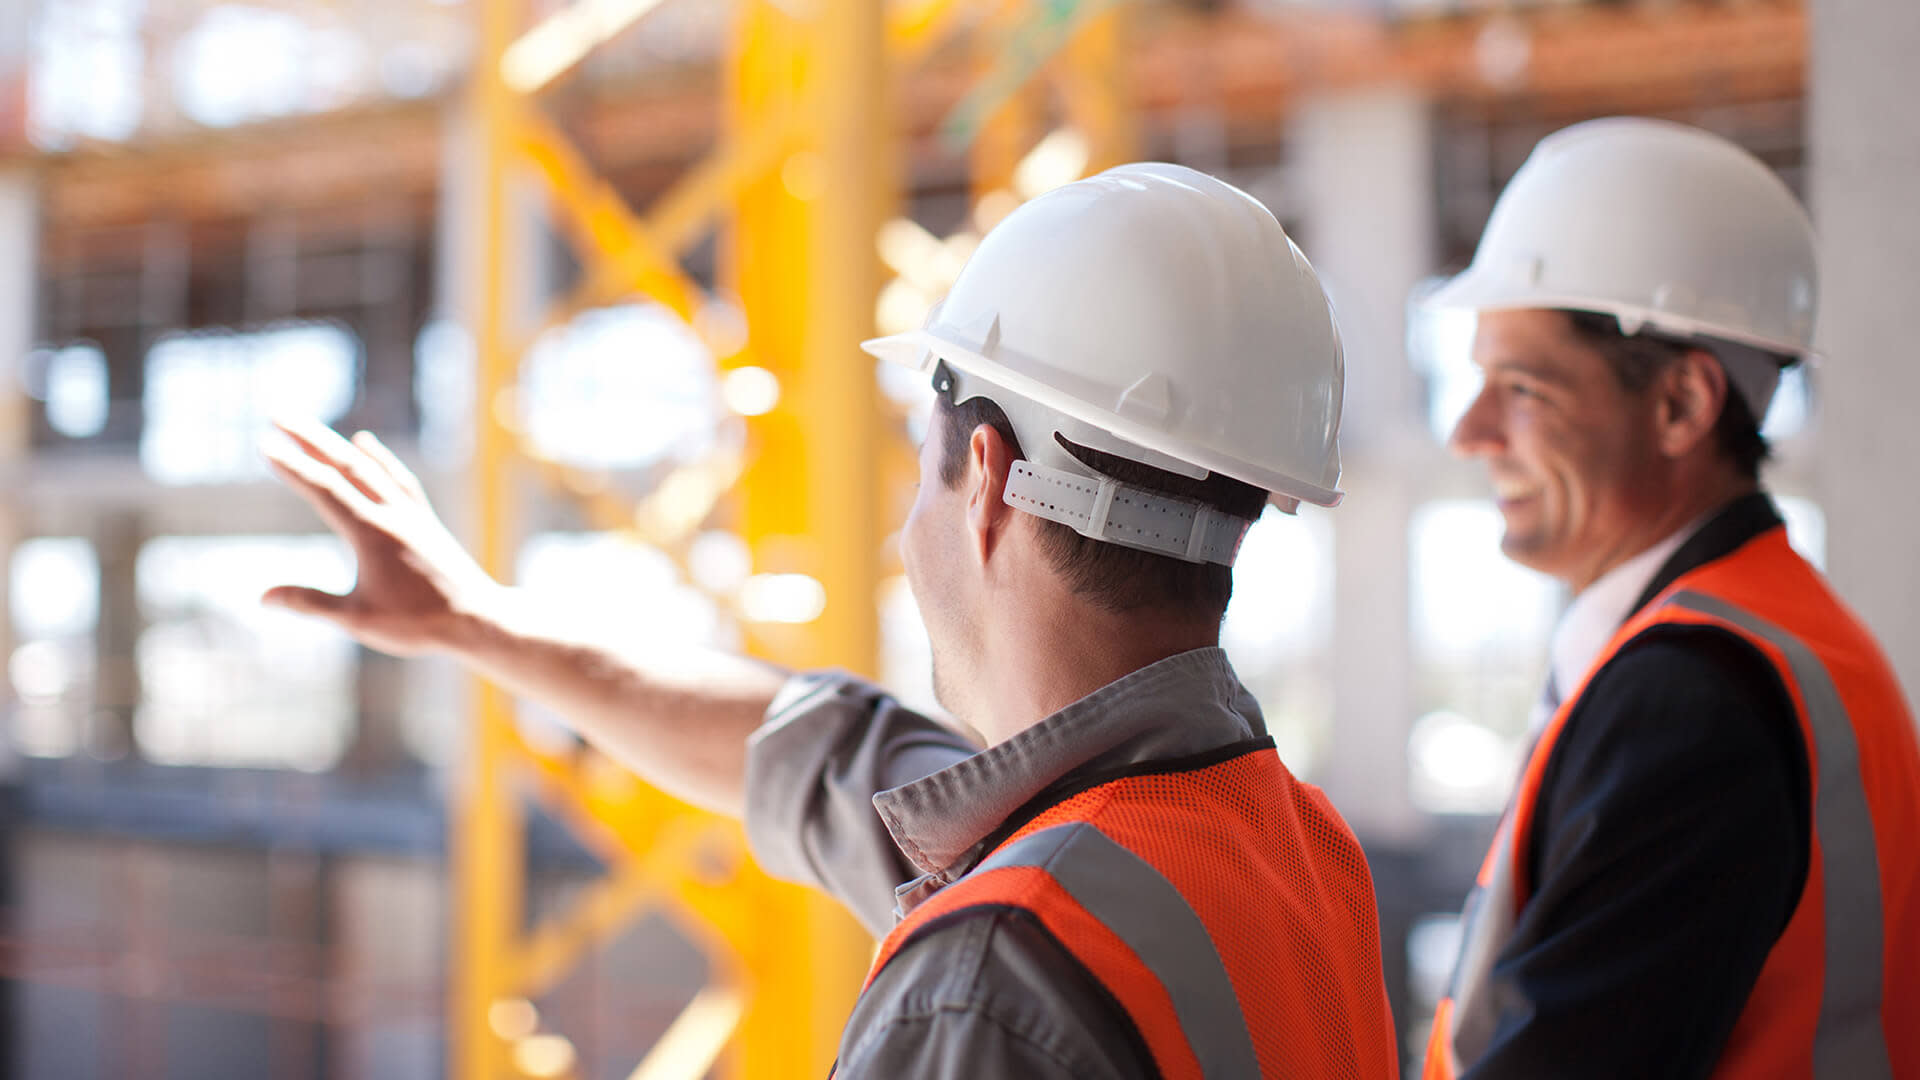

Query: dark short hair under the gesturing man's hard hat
937;396;1267;625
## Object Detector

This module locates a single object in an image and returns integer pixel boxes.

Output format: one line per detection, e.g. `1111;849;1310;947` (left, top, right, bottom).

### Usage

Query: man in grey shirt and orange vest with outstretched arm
267;165;1398;1080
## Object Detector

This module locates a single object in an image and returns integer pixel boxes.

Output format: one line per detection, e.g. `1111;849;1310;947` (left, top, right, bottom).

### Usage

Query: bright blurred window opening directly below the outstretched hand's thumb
134;536;357;771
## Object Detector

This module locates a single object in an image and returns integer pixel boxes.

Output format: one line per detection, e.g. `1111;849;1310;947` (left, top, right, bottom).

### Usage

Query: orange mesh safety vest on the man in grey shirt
868;740;1400;1080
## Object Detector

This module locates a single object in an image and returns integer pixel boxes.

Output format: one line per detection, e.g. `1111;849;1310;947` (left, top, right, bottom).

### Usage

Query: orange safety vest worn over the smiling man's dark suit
1425;527;1920;1080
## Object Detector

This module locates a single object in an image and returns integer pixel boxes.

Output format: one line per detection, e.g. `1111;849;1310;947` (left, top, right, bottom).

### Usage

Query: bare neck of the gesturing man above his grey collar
968;580;1219;746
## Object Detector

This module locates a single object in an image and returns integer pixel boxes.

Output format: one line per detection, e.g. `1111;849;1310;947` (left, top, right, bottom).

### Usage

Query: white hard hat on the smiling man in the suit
1427;117;1816;415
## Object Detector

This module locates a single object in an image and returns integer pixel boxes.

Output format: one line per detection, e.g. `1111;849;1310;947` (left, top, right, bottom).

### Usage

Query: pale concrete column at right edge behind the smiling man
1807;0;1920;701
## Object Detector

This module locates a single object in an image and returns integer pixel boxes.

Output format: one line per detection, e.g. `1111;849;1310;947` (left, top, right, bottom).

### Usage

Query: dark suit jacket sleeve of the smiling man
1463;628;1811;1080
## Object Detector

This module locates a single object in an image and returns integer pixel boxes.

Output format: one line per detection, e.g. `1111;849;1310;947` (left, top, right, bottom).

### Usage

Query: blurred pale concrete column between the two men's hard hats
1290;88;1434;842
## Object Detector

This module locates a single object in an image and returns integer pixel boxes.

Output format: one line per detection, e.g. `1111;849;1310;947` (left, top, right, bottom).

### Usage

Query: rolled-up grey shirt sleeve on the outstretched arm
745;673;977;936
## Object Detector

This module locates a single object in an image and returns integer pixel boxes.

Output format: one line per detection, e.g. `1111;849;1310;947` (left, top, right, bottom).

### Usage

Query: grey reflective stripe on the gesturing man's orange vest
973;822;1260;1080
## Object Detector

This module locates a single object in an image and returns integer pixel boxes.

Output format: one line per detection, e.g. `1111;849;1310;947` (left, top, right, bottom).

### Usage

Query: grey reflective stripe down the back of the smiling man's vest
1668;592;1893;1080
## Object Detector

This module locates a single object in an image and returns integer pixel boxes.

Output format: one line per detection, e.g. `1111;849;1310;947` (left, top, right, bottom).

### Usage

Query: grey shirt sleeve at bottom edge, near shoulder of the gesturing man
835;911;1156;1080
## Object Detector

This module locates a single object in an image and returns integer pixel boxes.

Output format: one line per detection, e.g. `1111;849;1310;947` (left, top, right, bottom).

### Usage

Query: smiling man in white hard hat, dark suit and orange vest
1425;119;1920;1080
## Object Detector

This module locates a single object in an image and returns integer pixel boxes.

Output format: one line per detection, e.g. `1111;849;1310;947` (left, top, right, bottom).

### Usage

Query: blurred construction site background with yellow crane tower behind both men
0;0;1920;1080
